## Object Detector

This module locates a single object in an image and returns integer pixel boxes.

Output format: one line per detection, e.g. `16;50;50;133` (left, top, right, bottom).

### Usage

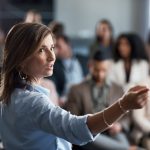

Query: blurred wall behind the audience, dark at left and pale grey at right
0;0;150;53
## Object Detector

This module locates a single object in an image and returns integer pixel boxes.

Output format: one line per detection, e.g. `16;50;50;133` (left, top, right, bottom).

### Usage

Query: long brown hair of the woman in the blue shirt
0;23;52;104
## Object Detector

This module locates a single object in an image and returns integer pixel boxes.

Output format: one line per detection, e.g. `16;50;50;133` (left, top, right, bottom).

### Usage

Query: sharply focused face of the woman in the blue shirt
22;34;55;80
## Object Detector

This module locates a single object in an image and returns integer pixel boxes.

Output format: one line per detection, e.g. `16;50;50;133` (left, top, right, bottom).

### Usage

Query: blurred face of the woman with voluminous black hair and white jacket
118;38;131;58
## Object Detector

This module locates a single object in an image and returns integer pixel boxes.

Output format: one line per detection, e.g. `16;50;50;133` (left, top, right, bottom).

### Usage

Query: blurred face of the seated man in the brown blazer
89;60;110;84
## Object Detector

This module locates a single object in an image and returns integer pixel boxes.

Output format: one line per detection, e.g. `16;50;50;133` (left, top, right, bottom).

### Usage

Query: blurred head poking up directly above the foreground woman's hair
24;10;42;23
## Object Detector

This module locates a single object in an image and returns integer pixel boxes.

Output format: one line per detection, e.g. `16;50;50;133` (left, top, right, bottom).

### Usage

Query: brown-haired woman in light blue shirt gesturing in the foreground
0;23;149;150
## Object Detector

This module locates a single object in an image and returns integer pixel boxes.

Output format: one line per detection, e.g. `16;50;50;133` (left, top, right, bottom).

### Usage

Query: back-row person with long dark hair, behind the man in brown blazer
89;19;113;55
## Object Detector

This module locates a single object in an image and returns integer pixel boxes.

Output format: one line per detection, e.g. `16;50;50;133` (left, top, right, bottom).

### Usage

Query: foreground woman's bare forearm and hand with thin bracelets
87;86;149;134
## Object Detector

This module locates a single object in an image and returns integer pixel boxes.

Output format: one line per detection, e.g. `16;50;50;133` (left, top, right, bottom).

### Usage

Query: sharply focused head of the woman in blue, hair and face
0;23;55;103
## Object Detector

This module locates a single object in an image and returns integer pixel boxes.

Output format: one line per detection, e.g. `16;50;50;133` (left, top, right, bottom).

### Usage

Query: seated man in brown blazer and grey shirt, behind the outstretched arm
65;50;130;150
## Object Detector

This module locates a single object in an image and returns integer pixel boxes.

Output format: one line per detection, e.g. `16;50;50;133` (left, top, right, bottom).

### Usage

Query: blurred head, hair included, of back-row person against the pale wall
96;19;113;43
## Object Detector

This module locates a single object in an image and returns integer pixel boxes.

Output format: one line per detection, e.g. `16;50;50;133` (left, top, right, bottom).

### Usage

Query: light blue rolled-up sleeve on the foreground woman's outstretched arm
30;96;96;145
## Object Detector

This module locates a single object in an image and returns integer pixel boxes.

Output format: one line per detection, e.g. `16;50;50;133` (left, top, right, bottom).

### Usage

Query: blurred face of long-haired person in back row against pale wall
96;23;112;40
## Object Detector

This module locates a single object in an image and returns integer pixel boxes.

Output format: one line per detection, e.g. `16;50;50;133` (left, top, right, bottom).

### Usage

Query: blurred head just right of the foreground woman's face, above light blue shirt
56;35;72;59
